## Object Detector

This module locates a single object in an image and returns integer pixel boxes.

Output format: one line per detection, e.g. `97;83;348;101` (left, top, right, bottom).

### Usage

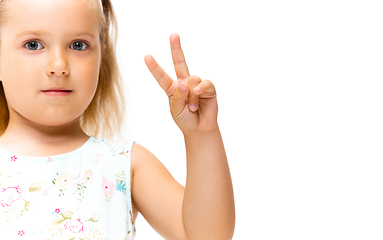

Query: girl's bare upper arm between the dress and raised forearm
127;143;188;239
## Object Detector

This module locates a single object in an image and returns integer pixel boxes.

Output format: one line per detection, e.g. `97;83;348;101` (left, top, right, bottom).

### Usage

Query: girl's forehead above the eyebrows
2;0;101;37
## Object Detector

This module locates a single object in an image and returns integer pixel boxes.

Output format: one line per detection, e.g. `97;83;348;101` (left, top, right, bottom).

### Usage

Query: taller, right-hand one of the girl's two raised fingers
170;33;190;81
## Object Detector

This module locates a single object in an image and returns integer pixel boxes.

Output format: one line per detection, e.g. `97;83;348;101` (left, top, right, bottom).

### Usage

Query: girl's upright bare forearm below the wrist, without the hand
182;129;235;239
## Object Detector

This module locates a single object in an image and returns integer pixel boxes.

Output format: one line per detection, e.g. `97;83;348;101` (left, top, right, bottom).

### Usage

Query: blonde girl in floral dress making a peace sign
0;0;235;240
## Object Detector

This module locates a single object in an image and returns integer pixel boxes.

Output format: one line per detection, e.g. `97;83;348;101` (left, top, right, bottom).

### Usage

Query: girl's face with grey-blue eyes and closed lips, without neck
0;0;101;126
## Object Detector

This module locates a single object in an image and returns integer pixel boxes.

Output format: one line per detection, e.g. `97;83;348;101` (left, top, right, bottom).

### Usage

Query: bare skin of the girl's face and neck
0;0;101;156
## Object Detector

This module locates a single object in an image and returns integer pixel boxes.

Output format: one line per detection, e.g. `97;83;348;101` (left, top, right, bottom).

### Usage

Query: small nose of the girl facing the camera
46;49;69;76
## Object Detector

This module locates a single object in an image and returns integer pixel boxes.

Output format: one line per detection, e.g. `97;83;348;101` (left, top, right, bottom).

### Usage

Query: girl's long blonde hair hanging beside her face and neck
0;0;126;140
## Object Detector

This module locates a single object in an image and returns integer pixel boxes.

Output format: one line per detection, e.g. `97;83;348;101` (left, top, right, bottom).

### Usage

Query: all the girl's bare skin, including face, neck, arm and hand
0;0;235;240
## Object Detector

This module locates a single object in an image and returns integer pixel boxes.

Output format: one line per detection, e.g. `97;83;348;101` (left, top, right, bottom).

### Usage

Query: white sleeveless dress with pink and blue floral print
0;136;135;240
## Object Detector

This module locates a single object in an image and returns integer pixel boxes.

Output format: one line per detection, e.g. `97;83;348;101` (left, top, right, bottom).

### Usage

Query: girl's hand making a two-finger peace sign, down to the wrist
145;33;218;134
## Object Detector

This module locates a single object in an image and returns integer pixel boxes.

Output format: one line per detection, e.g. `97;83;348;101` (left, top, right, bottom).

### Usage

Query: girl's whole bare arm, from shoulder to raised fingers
133;34;235;240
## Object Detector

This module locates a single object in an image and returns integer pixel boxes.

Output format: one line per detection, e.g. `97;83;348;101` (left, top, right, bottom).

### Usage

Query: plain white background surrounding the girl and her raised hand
113;0;383;240
